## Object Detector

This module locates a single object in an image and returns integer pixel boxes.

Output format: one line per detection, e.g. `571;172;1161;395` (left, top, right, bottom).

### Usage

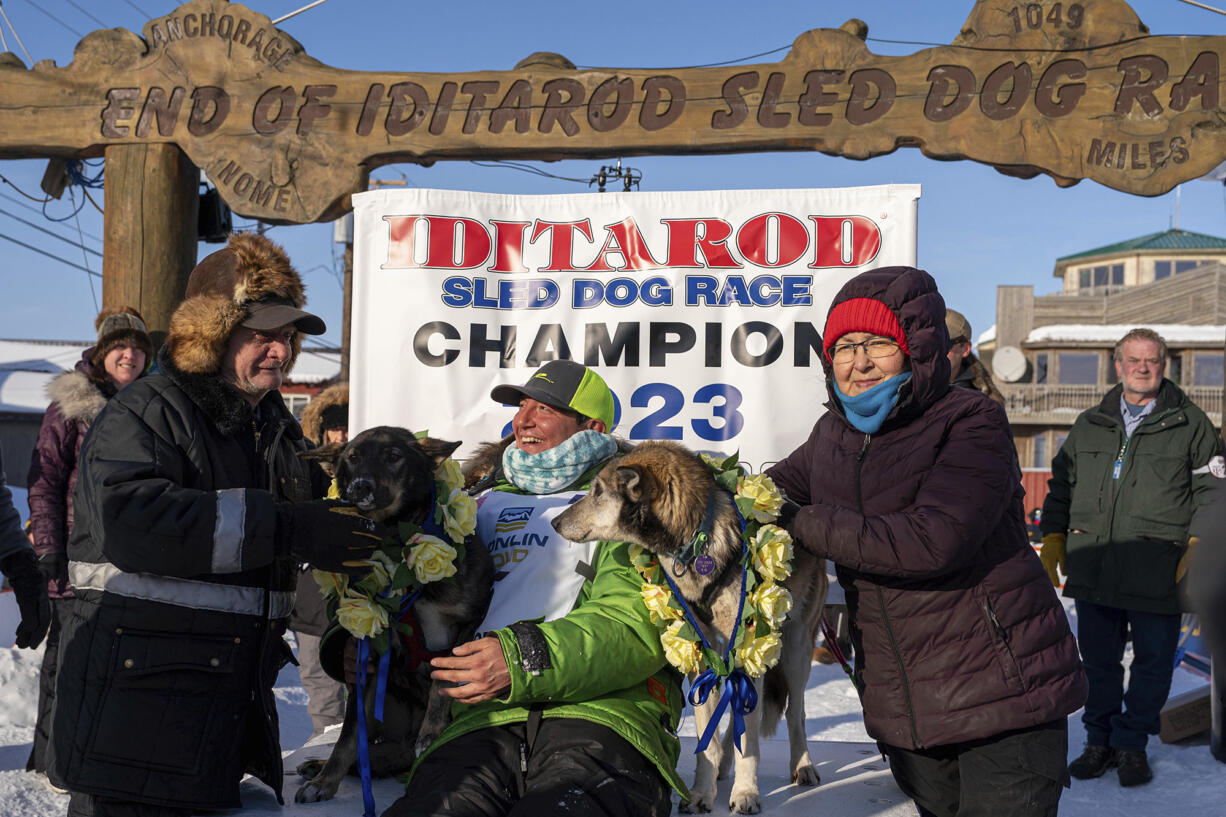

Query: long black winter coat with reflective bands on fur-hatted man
49;350;322;810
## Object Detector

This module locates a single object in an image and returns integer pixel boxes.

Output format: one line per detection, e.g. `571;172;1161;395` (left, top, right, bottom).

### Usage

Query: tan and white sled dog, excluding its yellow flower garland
553;442;826;815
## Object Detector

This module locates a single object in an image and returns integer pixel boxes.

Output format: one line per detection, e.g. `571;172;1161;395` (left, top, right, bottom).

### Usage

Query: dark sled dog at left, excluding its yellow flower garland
294;426;494;802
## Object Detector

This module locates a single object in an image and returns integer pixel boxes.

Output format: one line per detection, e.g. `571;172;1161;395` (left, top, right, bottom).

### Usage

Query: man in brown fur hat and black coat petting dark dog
48;234;379;817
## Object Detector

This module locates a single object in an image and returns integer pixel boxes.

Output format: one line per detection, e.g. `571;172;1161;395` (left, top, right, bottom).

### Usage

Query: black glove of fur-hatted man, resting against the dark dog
277;499;387;573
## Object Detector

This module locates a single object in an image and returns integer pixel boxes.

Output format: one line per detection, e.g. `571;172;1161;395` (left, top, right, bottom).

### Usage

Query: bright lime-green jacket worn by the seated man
411;472;689;800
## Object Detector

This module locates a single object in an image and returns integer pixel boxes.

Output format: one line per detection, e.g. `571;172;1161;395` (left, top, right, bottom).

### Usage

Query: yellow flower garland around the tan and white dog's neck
630;454;793;678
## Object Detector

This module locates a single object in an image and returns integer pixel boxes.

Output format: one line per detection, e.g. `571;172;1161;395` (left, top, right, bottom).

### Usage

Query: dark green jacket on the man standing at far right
1041;380;1221;613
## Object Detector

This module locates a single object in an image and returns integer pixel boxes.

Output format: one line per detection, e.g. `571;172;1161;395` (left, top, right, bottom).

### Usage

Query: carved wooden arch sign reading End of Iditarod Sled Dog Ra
0;0;1226;223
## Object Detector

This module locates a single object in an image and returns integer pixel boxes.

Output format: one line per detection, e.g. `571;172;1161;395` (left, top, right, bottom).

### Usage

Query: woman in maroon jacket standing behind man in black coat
26;301;153;773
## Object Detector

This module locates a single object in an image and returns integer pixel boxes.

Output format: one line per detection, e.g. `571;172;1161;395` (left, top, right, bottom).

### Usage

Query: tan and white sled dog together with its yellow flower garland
553;442;826;813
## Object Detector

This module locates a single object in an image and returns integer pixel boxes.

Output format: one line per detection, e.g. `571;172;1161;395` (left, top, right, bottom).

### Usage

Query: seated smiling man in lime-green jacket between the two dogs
384;361;688;817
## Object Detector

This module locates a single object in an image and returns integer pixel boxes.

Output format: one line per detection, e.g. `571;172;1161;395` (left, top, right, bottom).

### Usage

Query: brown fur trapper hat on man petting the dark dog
166;233;326;374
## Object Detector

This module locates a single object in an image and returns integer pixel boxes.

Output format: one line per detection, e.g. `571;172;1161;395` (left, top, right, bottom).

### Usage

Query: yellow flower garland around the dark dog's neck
313;459;477;654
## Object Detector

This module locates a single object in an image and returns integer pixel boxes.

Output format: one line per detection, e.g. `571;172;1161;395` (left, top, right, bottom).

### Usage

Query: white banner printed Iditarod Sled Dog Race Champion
349;184;920;470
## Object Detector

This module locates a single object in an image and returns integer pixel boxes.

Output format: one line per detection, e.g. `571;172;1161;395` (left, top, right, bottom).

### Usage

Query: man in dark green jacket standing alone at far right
1040;329;1226;786
